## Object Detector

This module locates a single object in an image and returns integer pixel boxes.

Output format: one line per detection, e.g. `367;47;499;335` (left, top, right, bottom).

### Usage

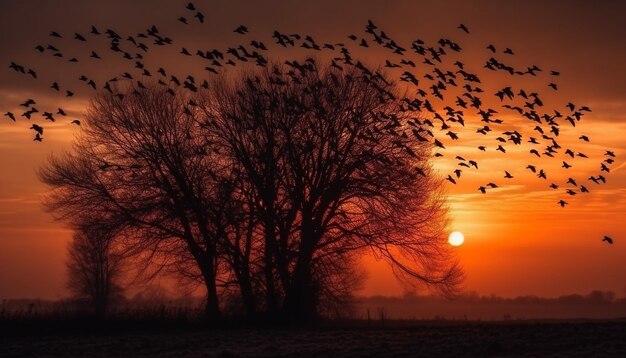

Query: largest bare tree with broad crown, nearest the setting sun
200;59;462;319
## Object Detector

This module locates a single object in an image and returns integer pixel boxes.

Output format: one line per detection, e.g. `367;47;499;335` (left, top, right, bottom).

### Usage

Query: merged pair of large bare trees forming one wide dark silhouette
40;59;462;321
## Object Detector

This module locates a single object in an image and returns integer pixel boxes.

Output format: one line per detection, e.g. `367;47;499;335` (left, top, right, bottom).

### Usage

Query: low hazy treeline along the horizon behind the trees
0;289;626;321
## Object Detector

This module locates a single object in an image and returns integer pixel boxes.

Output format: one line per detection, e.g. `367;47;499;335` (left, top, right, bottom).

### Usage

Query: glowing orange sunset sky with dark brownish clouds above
0;0;626;299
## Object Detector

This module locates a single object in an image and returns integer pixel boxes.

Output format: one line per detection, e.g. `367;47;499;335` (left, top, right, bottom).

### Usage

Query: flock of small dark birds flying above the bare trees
4;3;616;243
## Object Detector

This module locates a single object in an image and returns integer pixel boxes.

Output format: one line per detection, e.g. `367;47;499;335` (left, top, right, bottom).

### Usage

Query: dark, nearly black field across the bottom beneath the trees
0;321;626;358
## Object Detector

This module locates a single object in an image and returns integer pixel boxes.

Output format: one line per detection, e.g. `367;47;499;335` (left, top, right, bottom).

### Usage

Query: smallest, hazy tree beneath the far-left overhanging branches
67;227;123;317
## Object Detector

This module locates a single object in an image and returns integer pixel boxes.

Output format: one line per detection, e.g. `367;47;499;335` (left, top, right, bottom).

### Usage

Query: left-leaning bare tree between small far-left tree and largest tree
40;87;234;317
